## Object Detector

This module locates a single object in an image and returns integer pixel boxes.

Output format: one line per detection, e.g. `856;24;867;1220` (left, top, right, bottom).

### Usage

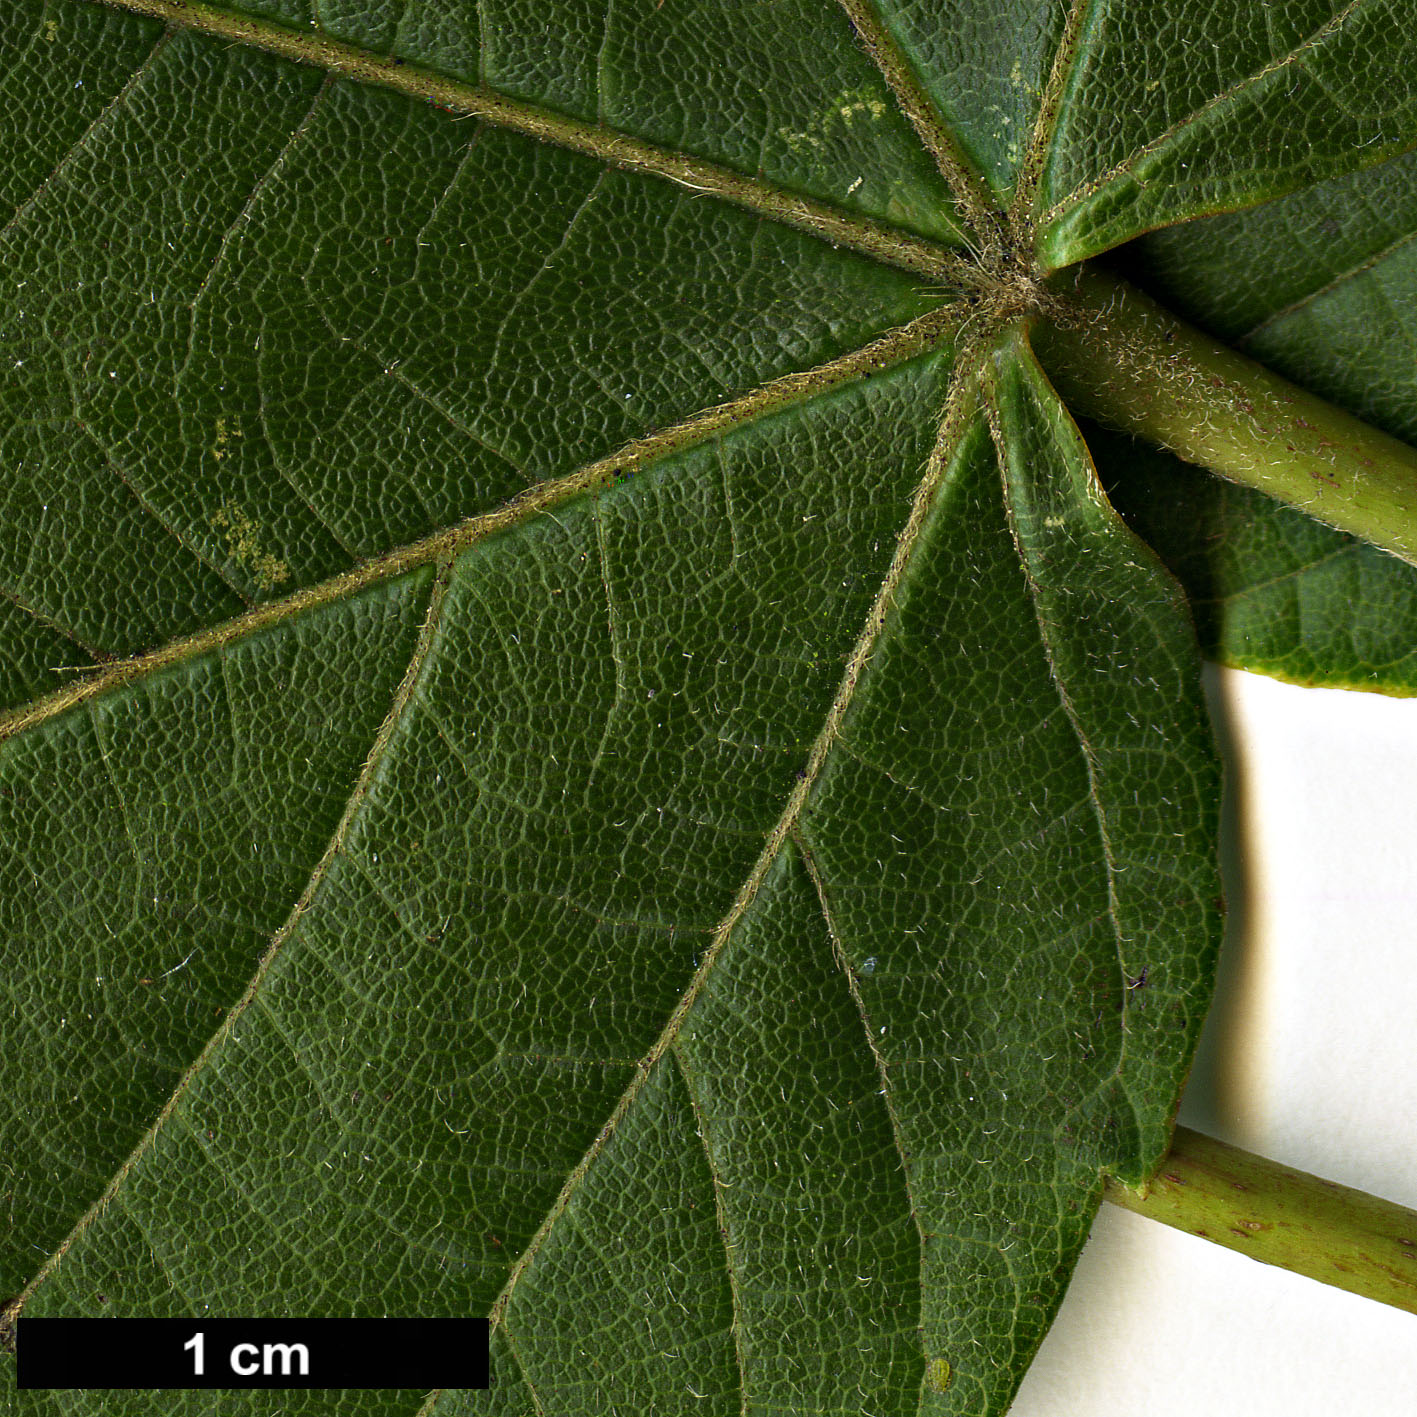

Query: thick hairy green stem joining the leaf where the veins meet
1034;268;1417;564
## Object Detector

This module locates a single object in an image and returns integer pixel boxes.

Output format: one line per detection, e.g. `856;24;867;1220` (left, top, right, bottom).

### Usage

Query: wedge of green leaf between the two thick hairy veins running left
0;0;931;701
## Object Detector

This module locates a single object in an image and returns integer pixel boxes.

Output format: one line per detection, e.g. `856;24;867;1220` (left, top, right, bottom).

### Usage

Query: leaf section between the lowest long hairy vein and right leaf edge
503;337;1219;1413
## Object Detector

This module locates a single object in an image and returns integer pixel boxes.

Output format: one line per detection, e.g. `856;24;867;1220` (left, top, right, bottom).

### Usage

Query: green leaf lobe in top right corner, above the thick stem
1036;0;1417;265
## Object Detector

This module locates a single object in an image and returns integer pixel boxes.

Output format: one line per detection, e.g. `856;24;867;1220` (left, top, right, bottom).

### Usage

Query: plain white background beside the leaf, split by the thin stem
1010;669;1417;1417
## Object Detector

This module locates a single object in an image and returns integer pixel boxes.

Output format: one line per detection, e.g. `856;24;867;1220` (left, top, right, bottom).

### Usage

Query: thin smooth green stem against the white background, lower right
1105;1127;1417;1314
